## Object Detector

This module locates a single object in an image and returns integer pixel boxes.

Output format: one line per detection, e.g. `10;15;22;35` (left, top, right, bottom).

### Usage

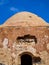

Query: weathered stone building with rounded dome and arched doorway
0;12;49;65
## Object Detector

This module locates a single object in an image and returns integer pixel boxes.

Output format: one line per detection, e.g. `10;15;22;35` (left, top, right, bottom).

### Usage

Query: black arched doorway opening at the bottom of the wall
21;54;32;65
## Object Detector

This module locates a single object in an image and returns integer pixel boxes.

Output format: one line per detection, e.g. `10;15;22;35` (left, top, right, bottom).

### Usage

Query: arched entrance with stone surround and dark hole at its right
18;52;41;65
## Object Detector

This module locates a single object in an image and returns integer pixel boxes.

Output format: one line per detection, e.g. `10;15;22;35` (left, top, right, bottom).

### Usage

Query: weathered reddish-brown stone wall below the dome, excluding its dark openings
0;26;49;65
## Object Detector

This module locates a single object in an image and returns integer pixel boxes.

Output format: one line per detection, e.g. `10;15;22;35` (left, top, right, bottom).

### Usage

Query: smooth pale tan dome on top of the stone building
2;12;49;26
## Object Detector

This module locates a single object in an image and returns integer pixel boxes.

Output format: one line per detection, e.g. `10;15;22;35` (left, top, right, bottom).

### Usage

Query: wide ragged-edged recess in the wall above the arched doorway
17;34;37;43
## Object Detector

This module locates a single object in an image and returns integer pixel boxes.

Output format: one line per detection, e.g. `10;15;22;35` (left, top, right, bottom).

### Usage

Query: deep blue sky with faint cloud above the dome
0;0;49;24
